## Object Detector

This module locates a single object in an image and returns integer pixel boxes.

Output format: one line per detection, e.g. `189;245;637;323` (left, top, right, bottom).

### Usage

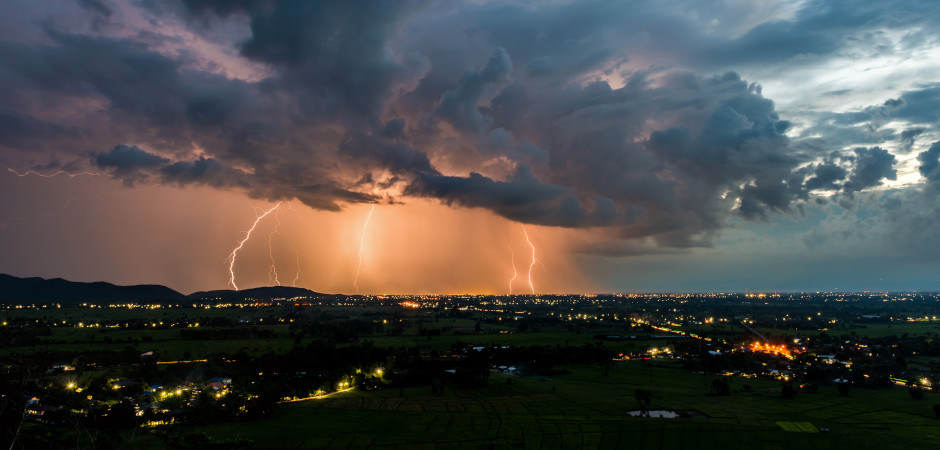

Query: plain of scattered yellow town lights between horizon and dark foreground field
3;294;940;446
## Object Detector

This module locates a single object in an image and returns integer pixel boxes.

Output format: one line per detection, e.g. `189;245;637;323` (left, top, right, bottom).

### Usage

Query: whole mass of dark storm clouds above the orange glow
0;0;940;254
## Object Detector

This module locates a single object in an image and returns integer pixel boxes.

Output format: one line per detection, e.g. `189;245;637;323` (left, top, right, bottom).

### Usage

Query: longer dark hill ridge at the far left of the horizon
0;274;187;303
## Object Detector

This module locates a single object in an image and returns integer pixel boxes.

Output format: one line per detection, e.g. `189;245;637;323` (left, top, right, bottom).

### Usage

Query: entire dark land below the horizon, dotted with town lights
0;294;940;448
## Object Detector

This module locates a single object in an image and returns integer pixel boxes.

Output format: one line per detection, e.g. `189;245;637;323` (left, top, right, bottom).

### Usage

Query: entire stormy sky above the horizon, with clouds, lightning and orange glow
0;0;940;294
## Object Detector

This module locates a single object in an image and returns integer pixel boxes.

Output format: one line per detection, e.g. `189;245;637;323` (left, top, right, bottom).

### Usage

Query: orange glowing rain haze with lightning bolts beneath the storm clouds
5;176;603;294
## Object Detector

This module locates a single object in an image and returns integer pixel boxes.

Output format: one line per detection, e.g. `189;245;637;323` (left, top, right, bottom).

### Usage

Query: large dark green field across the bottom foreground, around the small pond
173;361;940;449
